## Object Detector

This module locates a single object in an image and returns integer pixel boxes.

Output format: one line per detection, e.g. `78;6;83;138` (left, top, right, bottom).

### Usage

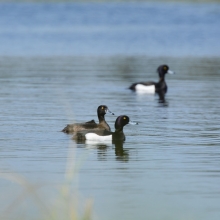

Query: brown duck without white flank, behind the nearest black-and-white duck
62;105;114;133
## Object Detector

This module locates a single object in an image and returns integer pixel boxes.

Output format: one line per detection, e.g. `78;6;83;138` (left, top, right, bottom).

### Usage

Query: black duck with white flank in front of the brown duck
73;115;138;141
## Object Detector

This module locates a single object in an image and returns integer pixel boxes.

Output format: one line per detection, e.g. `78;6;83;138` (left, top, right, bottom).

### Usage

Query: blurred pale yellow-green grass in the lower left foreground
0;142;92;220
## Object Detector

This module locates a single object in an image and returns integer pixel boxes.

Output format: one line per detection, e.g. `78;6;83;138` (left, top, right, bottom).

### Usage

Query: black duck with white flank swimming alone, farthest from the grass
129;64;174;94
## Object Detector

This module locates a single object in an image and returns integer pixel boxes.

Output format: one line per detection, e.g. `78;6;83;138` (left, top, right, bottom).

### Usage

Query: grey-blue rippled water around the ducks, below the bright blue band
0;56;220;220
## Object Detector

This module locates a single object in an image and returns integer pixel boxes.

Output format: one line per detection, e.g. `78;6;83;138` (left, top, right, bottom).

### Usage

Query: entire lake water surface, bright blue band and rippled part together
0;3;220;220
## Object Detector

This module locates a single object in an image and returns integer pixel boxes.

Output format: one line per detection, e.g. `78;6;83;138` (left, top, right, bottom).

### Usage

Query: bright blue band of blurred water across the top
0;3;220;56
